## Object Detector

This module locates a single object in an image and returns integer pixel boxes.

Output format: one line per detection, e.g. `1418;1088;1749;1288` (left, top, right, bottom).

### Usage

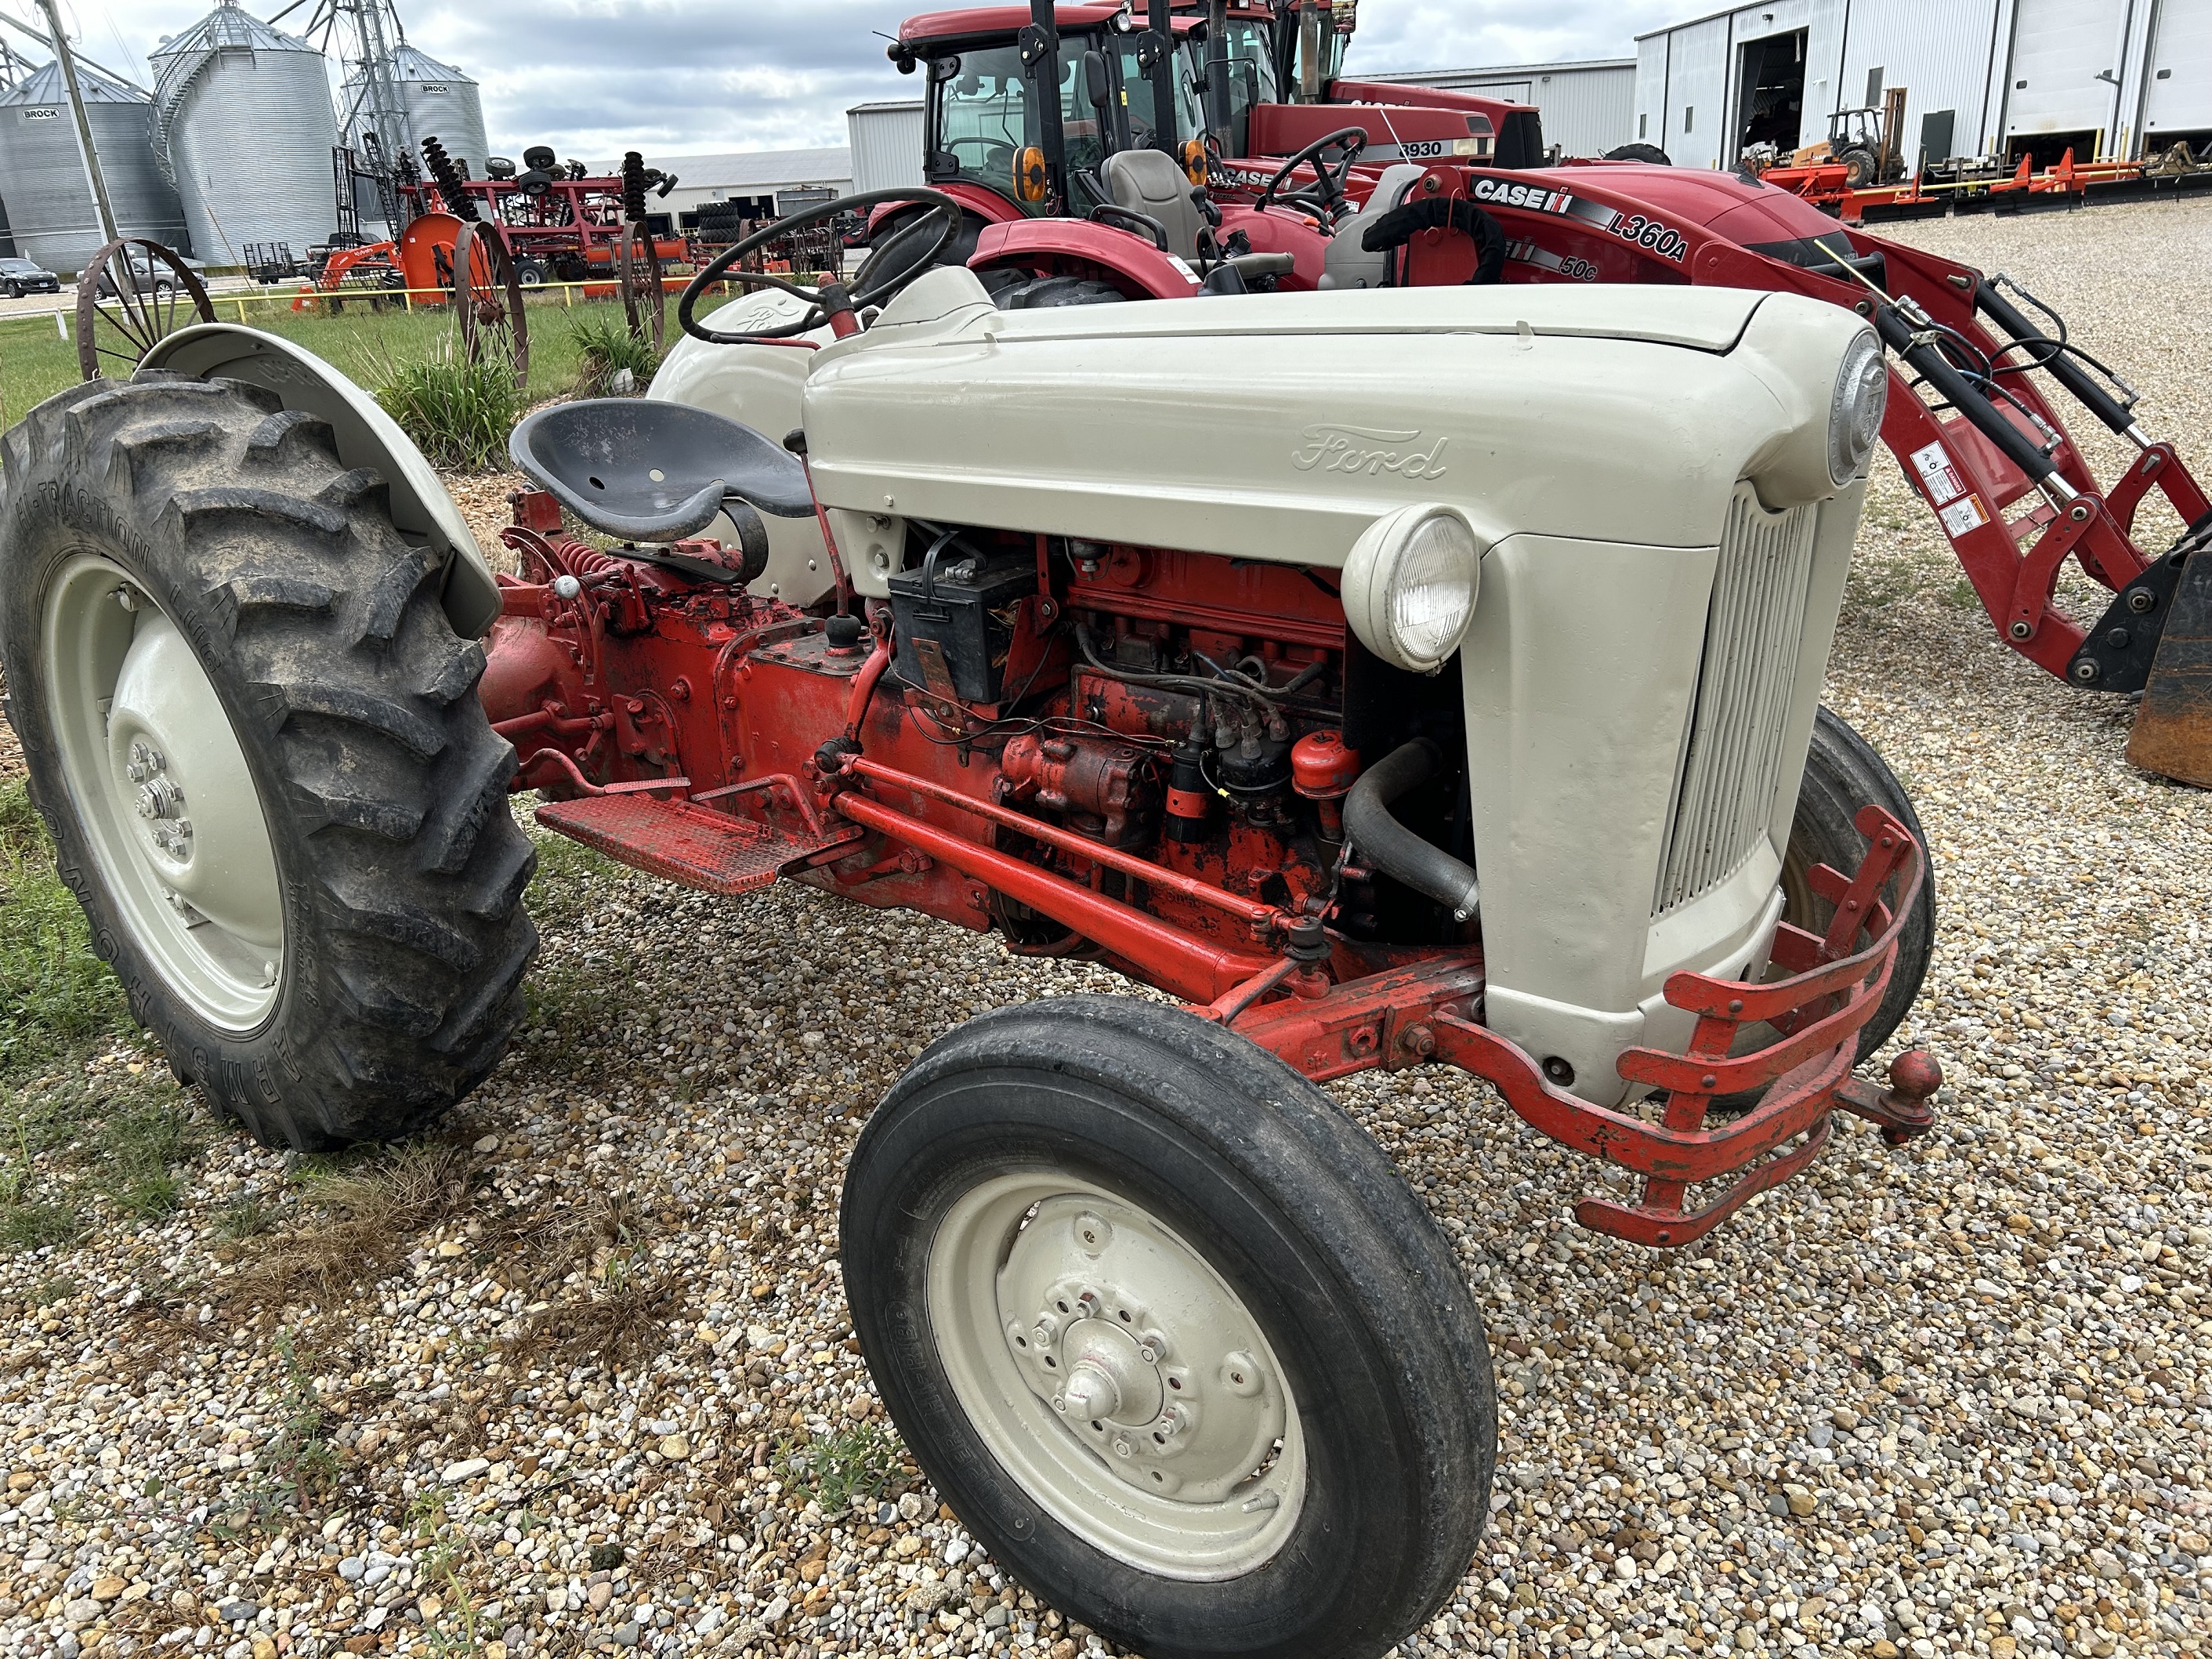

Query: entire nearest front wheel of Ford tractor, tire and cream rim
841;998;1497;1659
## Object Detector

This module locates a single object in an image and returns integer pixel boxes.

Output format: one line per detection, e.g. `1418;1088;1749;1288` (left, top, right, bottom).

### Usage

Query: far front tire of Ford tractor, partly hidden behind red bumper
1783;705;1935;1060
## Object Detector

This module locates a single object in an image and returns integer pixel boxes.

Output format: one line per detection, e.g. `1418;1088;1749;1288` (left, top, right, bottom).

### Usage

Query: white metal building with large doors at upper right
1635;0;2212;168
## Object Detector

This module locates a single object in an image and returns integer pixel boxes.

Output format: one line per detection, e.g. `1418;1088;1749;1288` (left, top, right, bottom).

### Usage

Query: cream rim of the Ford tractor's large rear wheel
40;553;283;1033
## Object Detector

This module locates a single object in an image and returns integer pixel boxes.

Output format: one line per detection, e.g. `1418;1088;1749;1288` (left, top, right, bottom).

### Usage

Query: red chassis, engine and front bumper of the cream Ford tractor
480;513;1942;1245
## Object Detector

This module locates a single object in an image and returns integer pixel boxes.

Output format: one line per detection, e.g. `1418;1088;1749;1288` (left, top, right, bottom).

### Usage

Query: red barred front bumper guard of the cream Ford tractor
1232;807;1942;1245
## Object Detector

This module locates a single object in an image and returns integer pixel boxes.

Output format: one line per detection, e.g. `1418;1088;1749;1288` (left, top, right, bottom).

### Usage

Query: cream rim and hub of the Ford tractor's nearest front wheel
927;1170;1305;1581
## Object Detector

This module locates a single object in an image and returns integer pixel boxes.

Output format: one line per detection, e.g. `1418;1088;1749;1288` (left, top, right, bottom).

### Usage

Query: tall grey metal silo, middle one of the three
150;0;338;266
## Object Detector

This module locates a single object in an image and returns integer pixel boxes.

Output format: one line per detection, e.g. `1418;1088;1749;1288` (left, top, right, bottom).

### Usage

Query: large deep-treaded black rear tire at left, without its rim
0;369;538;1150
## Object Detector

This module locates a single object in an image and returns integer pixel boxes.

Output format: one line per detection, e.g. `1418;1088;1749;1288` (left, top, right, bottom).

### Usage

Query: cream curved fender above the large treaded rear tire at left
142;323;500;639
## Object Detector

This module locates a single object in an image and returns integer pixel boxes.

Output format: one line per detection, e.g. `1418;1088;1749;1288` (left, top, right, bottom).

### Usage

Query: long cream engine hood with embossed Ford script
794;268;1865;592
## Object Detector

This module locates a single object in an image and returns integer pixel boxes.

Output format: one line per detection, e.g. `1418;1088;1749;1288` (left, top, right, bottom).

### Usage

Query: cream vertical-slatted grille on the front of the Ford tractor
1653;487;1816;916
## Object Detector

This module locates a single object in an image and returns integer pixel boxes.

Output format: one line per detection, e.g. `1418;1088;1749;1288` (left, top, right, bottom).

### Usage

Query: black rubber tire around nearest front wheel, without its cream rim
841;998;1497;1659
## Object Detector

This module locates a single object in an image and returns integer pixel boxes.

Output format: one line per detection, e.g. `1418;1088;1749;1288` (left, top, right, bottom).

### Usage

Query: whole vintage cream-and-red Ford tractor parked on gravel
0;197;1940;1659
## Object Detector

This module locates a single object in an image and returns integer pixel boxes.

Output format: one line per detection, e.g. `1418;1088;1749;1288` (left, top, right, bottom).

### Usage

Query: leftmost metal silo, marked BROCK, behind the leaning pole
0;62;186;272
